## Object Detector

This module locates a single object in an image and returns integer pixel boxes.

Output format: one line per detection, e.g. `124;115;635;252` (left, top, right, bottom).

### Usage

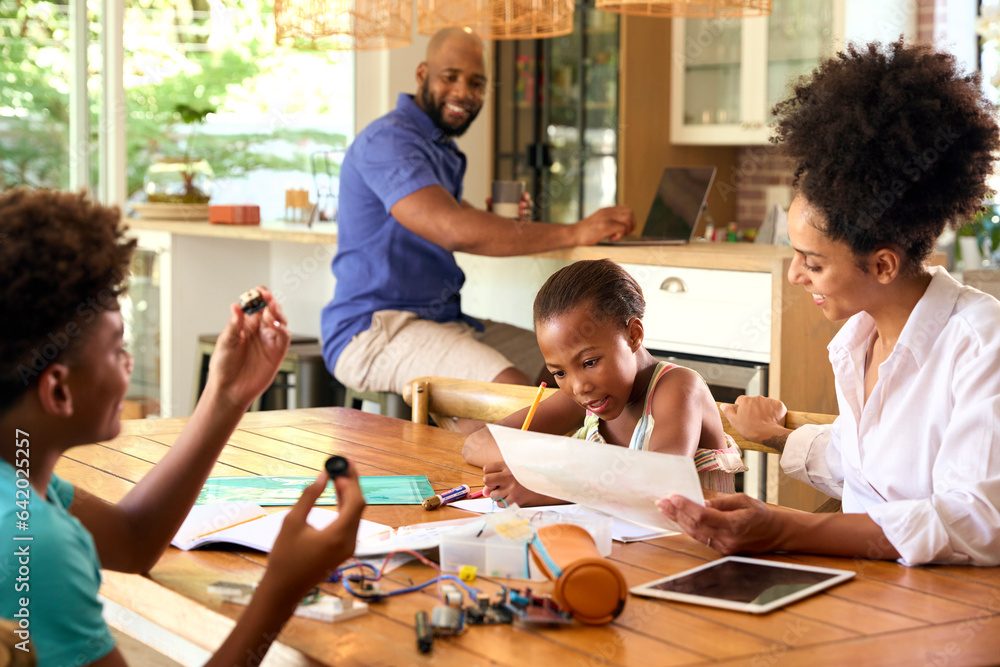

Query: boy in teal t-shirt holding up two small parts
0;189;364;667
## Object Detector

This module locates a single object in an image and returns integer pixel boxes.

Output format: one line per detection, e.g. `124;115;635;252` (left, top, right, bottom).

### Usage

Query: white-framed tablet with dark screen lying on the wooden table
631;556;854;614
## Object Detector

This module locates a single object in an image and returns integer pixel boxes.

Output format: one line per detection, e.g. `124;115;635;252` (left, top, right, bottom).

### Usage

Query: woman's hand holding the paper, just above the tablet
656;493;782;556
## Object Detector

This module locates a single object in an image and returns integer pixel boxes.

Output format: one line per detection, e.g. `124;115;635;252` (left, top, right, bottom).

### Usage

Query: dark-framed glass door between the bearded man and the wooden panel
494;0;618;223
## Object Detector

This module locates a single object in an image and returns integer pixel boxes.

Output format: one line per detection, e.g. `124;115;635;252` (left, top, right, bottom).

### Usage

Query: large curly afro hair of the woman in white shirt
772;38;1000;271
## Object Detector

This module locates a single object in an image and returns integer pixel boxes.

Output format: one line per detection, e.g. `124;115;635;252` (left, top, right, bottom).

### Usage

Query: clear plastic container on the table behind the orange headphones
440;508;612;581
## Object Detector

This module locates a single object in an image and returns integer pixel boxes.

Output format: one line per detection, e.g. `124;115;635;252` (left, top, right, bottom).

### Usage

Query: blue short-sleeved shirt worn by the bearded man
322;94;482;372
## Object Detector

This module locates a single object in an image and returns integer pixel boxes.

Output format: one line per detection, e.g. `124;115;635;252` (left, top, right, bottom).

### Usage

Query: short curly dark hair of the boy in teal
0;189;136;413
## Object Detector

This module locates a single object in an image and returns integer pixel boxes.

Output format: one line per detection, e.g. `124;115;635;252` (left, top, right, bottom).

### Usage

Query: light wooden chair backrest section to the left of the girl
403;376;559;424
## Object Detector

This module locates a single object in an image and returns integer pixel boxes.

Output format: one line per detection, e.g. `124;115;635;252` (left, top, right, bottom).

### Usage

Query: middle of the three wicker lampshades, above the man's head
417;0;574;39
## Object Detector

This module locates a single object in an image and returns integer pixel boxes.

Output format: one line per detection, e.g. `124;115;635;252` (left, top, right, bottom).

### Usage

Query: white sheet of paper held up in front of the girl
488;424;705;532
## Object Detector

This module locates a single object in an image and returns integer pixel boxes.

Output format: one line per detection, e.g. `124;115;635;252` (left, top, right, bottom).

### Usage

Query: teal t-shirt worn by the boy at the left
0;460;115;667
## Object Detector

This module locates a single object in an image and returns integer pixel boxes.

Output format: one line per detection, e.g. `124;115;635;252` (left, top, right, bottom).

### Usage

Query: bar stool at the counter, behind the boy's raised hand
194;334;344;410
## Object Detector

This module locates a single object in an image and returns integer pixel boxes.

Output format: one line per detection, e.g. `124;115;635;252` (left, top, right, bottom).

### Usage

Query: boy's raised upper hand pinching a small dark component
208;286;291;409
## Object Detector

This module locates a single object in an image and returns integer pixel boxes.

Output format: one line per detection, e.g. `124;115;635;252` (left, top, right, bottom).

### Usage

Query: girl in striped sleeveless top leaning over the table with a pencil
463;259;746;505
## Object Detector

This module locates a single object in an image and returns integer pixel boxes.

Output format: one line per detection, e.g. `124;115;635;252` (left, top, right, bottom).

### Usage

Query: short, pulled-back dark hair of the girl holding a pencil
534;259;646;327
